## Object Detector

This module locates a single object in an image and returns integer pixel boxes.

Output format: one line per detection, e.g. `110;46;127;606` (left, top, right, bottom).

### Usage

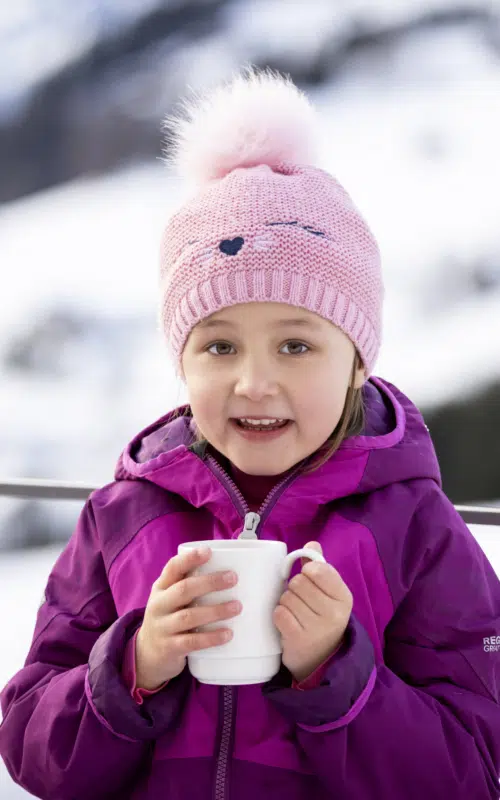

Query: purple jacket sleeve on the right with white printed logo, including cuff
264;487;500;800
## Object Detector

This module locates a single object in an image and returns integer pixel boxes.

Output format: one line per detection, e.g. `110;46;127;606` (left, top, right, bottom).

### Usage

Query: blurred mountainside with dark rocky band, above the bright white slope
0;0;500;202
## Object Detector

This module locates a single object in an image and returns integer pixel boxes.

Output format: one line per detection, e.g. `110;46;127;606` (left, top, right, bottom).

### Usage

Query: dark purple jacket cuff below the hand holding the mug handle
262;614;375;727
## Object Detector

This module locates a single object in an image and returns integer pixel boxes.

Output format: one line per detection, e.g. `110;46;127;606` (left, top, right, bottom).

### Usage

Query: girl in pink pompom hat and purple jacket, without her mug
0;72;500;800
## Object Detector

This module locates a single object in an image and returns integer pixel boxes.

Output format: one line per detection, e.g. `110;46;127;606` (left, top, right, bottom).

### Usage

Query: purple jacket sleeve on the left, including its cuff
0;498;190;800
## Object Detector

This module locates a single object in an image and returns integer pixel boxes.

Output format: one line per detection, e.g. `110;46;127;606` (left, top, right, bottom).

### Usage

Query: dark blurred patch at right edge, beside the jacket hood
422;381;500;504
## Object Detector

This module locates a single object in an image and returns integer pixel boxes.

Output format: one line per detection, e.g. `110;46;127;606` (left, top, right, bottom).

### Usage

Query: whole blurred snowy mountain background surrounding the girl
0;0;500;800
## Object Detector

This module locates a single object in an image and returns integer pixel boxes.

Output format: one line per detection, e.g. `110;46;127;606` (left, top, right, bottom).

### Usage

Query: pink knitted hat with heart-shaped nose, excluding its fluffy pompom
160;160;384;376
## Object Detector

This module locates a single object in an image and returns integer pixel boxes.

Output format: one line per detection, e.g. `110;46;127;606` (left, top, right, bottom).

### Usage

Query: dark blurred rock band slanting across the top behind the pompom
0;0;500;203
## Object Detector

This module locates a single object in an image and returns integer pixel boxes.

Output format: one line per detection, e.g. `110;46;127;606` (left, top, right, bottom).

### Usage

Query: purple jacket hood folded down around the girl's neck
115;377;441;516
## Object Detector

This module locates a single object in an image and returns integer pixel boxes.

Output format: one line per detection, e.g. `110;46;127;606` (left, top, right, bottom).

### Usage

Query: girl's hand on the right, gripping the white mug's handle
274;542;353;683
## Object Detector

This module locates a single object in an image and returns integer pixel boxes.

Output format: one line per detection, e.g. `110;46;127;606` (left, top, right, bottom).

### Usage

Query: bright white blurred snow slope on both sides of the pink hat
0;0;500;552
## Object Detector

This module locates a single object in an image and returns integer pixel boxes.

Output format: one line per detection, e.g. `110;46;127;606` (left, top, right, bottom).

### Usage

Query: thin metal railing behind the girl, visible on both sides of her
0;478;500;527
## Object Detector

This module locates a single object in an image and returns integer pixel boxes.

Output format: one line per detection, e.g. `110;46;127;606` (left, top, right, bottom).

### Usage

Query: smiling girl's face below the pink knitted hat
182;302;365;475
